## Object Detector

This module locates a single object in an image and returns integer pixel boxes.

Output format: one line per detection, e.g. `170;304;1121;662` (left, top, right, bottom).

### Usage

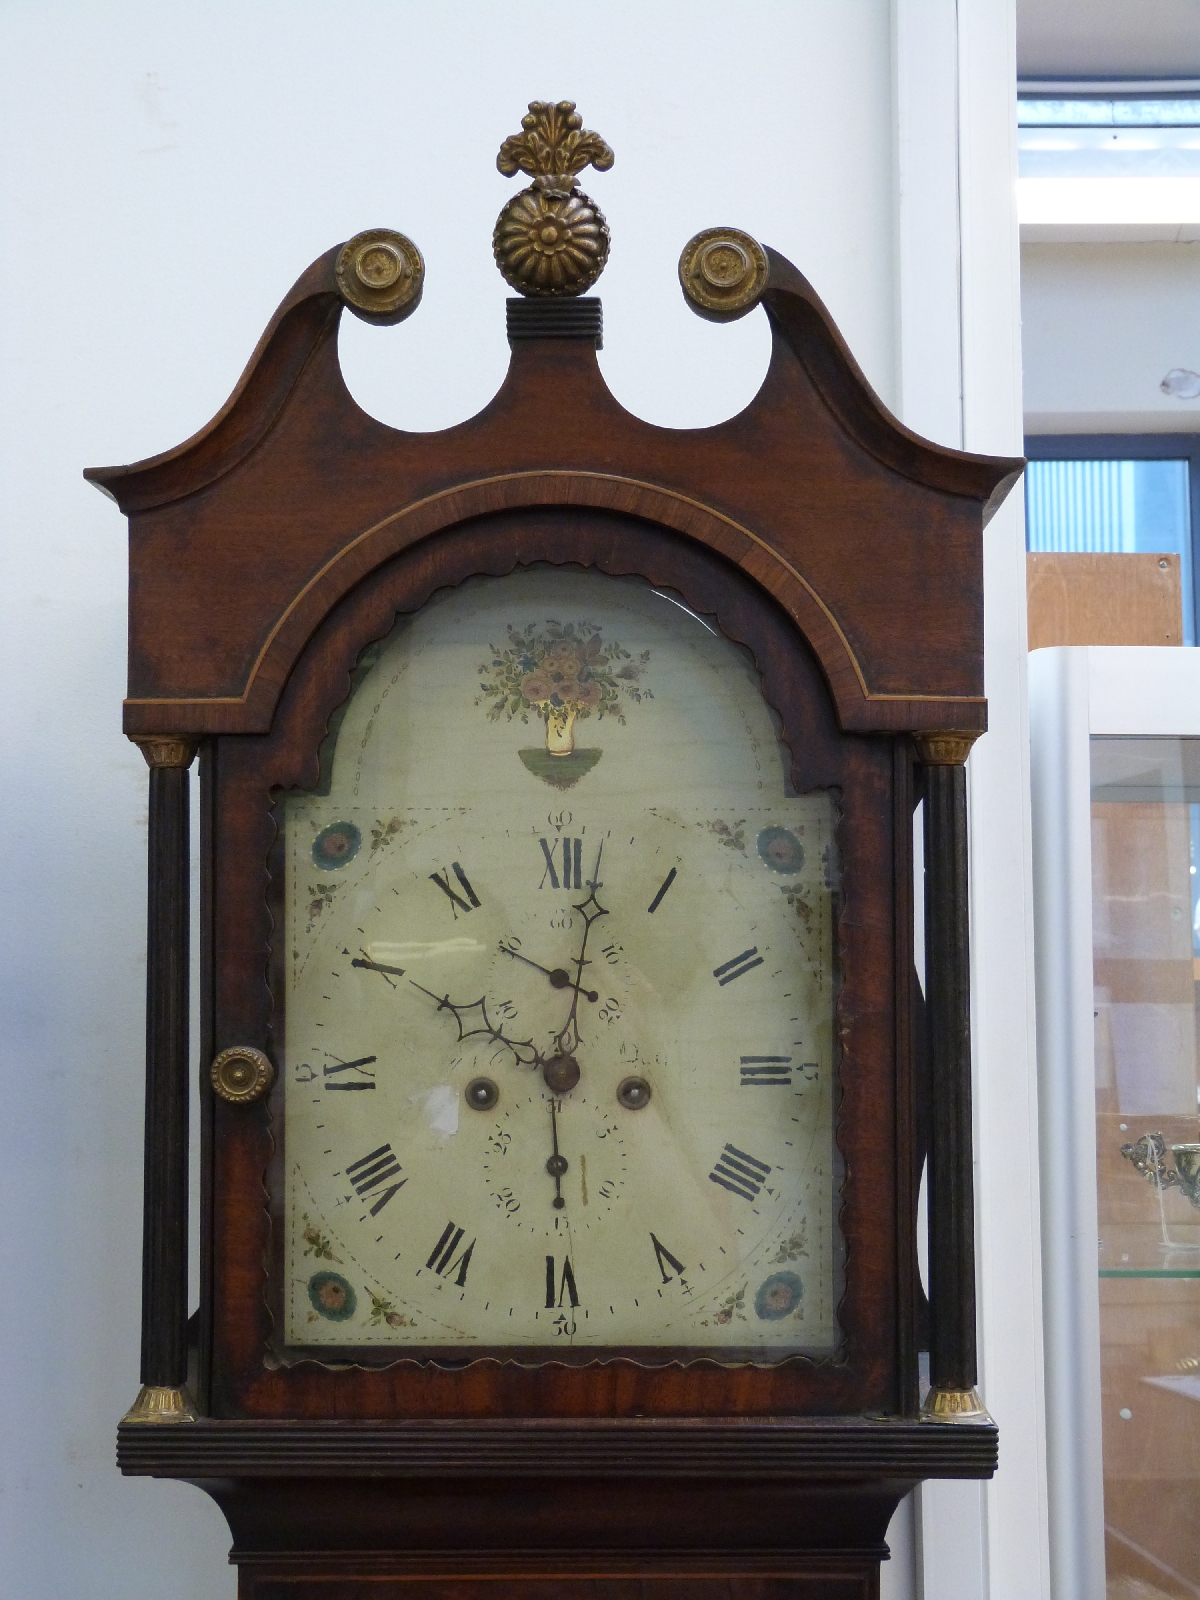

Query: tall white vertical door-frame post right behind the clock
894;0;1049;1600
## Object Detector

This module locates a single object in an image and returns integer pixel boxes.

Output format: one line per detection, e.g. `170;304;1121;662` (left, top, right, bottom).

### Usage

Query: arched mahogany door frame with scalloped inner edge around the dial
209;507;917;1418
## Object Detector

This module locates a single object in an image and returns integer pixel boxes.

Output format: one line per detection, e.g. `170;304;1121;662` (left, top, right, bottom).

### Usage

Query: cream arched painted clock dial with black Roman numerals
277;568;842;1362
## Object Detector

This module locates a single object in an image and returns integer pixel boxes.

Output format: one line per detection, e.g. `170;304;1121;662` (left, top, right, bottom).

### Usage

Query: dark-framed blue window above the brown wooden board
1026;434;1200;645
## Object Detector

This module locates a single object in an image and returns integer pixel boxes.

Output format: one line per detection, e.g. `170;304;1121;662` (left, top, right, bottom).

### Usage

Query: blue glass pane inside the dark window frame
1026;461;1195;645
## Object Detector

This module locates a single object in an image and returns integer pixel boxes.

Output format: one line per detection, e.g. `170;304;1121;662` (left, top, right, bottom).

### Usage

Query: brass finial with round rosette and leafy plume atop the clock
491;101;614;296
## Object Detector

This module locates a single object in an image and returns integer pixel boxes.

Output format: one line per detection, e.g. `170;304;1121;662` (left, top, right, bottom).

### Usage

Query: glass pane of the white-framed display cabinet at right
1091;739;1200;1600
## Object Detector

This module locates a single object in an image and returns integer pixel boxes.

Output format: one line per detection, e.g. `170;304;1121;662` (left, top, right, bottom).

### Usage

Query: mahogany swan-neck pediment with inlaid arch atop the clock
86;241;1021;733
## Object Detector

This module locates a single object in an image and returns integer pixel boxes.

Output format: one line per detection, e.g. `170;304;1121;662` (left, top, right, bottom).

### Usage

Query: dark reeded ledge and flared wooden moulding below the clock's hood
118;1418;997;1600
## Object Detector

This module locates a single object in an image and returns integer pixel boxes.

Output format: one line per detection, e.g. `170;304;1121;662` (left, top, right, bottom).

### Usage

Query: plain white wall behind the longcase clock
0;0;1042;1600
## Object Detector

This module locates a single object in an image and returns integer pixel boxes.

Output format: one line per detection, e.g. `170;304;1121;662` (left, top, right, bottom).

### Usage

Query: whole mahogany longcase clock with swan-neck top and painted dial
88;101;1021;1600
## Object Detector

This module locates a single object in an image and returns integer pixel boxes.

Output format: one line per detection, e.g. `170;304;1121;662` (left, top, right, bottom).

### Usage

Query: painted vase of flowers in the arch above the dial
475;621;654;789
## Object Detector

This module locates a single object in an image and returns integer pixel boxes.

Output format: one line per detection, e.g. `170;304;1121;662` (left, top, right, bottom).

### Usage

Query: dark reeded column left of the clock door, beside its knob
125;738;195;1422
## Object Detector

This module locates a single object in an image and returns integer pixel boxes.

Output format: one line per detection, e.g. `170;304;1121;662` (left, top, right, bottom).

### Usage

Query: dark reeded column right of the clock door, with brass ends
917;733;990;1422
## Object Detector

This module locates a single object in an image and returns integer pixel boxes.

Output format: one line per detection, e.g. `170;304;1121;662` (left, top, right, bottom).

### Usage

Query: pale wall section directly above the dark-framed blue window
1021;242;1200;434
